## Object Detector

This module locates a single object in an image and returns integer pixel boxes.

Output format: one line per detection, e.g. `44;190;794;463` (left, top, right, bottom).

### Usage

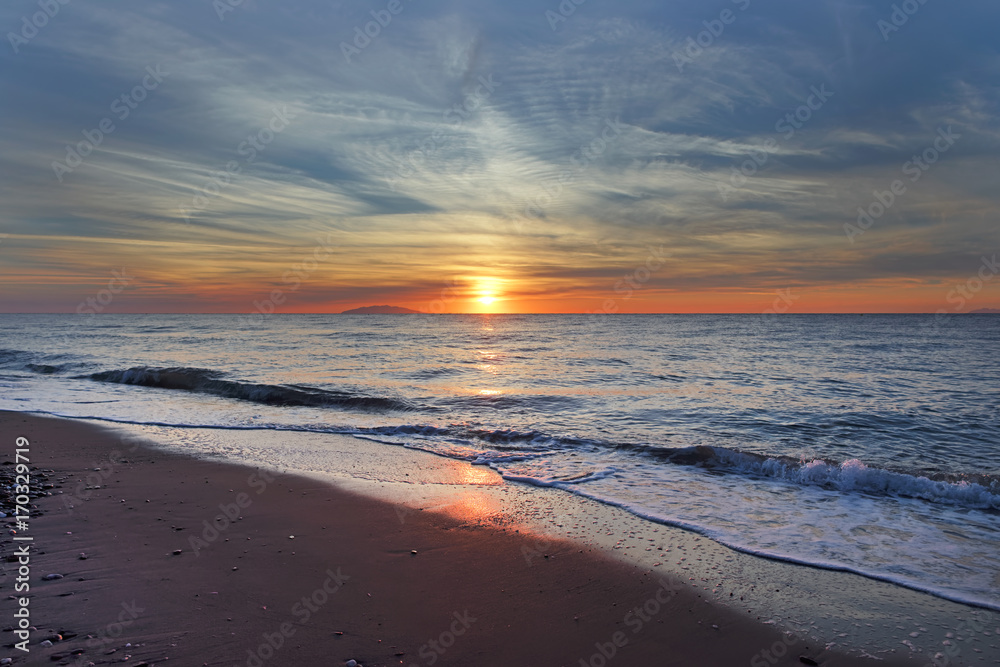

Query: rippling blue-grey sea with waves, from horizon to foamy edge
0;315;1000;610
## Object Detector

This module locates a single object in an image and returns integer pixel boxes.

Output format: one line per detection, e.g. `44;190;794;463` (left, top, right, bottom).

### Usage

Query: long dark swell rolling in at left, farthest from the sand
79;366;413;412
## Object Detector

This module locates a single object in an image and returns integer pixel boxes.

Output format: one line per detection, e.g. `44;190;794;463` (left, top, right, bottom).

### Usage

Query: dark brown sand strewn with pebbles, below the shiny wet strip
0;412;955;667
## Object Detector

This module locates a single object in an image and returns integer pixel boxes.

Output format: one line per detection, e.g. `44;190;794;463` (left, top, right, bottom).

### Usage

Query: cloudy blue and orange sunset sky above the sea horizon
0;0;1000;313
